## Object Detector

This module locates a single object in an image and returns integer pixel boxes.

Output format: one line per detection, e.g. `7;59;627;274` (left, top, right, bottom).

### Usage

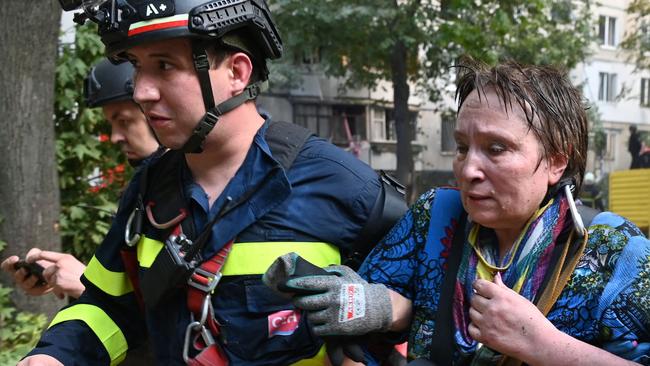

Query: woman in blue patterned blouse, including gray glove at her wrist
264;62;650;365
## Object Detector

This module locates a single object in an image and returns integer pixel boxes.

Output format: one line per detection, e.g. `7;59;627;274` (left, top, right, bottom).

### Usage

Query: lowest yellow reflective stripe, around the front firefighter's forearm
48;304;129;366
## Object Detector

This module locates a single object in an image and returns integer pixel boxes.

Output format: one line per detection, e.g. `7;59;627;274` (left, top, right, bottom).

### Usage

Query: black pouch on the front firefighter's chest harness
140;236;194;308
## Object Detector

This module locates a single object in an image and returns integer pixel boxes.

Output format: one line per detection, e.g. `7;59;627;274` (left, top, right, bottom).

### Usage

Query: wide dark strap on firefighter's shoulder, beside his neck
264;121;313;170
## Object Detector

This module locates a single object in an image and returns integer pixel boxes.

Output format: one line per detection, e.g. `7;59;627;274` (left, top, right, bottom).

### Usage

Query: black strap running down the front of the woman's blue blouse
429;211;467;366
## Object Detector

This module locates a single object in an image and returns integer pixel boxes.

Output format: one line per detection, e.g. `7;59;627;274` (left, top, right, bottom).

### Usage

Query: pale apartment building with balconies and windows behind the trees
260;0;650;190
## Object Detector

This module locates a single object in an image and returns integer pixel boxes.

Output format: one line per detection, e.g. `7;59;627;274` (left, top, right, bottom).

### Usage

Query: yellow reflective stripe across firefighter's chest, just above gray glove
221;241;341;276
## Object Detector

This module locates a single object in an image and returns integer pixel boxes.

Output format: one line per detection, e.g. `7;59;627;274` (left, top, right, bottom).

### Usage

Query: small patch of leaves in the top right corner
621;0;650;70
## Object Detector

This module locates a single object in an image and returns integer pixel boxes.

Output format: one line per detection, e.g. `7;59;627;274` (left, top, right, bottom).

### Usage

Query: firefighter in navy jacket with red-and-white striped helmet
20;0;406;365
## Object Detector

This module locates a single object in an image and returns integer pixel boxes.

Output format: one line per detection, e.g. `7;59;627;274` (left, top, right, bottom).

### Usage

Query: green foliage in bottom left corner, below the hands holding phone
0;218;47;365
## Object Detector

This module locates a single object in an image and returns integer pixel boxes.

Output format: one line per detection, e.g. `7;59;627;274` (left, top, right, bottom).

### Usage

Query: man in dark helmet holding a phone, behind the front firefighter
0;59;159;299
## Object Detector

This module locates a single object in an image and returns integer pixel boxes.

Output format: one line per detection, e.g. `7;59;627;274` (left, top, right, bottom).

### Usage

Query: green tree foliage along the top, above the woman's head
272;0;592;101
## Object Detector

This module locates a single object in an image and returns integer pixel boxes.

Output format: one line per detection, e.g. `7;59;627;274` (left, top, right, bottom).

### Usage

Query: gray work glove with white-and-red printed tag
286;266;393;336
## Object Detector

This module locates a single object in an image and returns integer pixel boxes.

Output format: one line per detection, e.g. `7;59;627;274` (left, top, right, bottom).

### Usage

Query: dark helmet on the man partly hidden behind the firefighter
84;59;133;108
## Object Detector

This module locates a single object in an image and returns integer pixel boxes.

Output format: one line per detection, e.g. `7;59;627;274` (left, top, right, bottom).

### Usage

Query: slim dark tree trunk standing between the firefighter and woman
391;41;414;201
